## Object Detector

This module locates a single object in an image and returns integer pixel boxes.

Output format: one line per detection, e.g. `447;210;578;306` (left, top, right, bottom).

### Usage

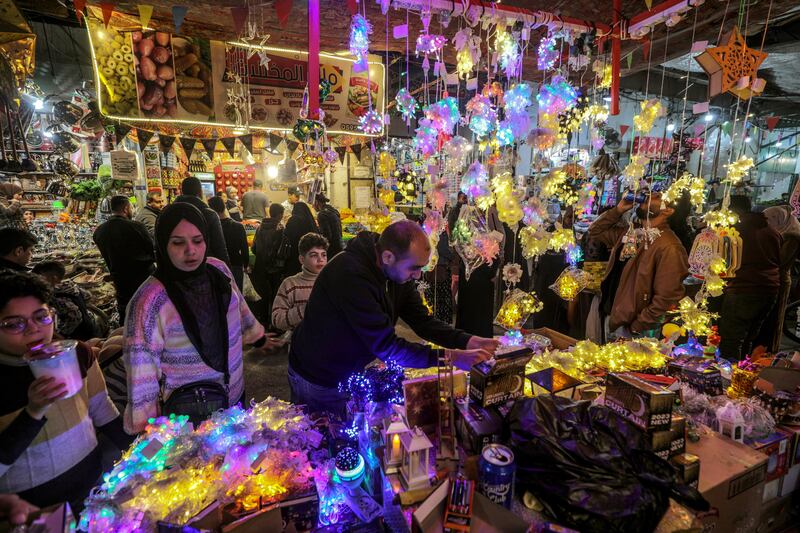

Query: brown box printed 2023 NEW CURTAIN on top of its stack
604;373;675;431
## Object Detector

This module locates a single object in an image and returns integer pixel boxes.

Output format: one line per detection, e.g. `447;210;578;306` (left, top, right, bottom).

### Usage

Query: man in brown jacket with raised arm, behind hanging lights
589;192;689;338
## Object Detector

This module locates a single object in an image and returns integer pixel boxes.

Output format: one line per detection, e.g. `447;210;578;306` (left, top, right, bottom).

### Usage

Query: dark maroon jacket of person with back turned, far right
726;213;783;294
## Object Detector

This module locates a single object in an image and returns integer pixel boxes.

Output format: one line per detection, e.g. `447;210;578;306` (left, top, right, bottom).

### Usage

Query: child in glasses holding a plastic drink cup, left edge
0;271;130;508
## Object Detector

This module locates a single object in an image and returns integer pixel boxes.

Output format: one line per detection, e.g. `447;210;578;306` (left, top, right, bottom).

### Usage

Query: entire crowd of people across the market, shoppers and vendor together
0;178;800;520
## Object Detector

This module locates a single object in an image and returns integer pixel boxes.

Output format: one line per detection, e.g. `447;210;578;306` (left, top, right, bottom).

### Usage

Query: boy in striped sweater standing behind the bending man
272;233;328;331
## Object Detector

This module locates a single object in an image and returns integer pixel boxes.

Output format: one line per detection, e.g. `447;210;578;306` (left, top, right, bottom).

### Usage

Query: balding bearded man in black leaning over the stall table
289;220;498;416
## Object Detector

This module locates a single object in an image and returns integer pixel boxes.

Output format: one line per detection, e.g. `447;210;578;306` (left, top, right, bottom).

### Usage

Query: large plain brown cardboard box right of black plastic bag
686;431;767;531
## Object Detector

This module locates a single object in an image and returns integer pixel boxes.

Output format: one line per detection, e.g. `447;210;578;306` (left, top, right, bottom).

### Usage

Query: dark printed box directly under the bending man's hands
469;348;533;407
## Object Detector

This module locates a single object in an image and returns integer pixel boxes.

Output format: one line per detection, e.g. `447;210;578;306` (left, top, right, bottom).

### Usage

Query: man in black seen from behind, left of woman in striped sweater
93;196;155;324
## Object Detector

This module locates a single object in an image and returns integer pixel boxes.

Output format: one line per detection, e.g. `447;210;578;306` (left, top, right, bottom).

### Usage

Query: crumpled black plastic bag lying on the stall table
509;395;708;533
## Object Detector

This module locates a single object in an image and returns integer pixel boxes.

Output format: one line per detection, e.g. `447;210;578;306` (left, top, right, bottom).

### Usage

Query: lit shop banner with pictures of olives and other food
89;20;385;135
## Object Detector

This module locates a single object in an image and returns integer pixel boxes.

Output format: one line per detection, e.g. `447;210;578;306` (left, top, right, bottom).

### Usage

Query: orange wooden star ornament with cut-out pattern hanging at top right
694;27;768;100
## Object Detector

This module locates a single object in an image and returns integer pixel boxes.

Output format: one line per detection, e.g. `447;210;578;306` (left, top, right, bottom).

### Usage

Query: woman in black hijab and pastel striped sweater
124;202;268;434
